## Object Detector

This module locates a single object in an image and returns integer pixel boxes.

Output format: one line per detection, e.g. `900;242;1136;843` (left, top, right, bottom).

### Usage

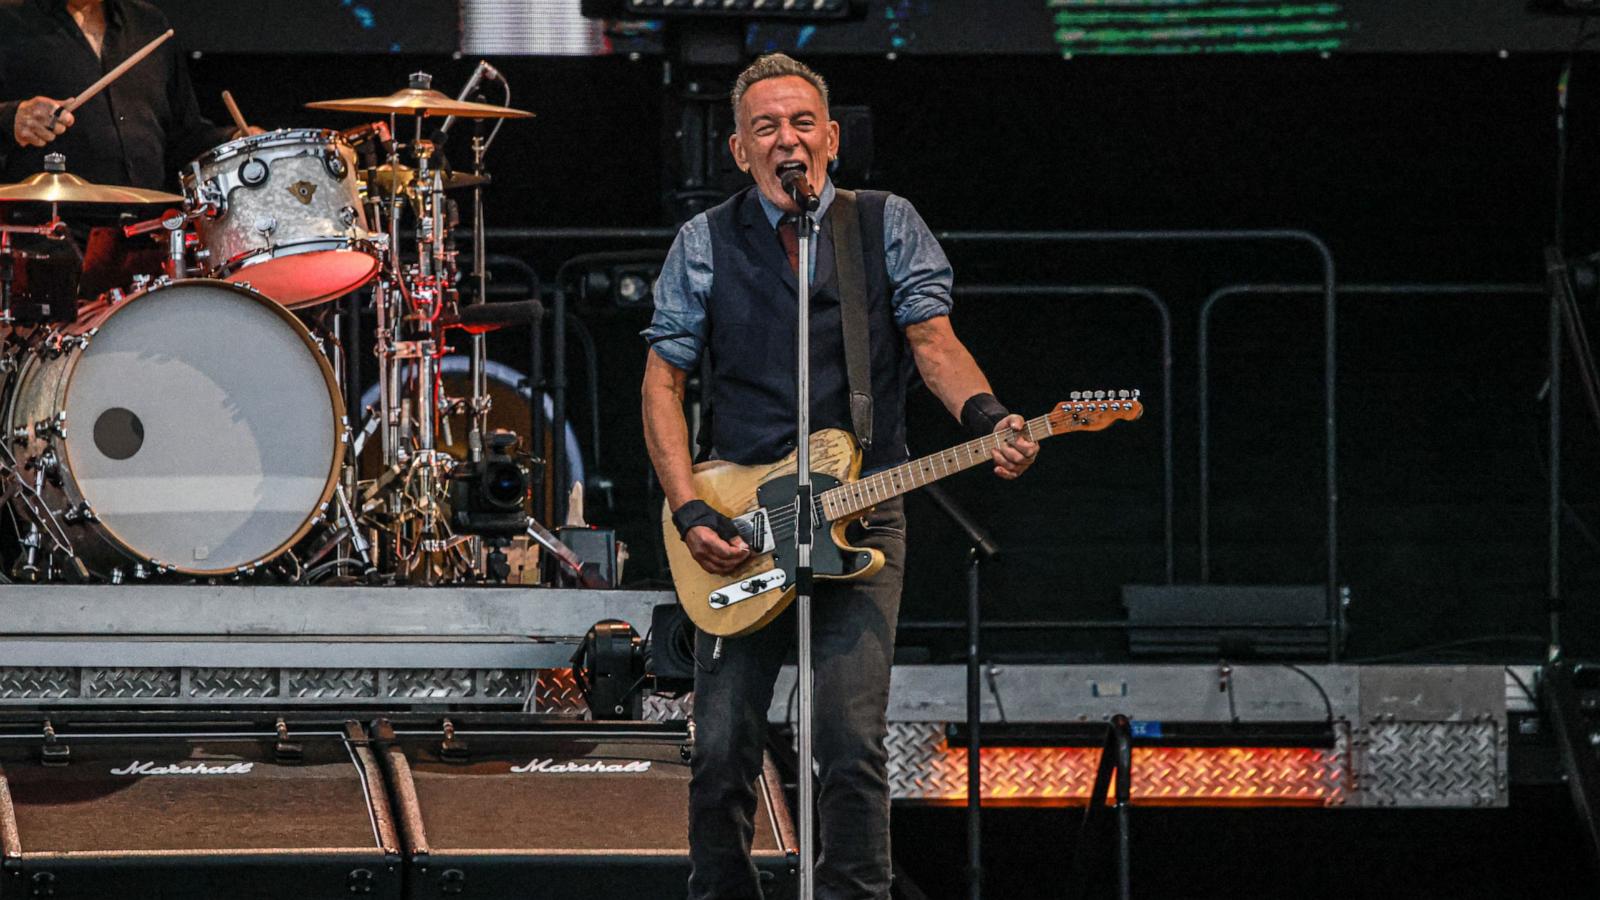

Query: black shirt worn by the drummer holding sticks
0;0;229;191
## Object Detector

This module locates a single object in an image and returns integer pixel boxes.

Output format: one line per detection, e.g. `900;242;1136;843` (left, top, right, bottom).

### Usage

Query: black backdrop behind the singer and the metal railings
172;47;1600;655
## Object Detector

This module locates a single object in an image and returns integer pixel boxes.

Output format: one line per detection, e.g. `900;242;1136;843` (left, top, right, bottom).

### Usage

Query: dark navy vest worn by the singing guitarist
706;186;910;469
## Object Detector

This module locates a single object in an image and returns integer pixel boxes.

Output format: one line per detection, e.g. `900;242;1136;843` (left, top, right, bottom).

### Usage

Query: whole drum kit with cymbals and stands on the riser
0;74;569;585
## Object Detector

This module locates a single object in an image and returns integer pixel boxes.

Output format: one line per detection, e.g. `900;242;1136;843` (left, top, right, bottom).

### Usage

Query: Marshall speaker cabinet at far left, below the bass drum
0;716;402;900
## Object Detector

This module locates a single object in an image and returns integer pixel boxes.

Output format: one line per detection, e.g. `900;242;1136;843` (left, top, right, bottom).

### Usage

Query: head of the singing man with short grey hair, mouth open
728;75;838;213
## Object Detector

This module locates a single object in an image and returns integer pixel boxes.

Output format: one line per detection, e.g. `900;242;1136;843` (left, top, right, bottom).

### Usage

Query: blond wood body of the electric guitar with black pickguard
661;429;883;637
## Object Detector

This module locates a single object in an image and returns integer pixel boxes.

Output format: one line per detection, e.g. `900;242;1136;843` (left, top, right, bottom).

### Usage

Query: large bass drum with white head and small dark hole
5;279;346;578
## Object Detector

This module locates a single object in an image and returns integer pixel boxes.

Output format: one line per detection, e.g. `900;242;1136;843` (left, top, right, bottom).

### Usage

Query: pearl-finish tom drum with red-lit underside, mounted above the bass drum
184;128;379;309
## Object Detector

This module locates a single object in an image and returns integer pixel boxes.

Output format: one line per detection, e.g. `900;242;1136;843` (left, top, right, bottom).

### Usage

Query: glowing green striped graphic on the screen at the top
1048;0;1350;56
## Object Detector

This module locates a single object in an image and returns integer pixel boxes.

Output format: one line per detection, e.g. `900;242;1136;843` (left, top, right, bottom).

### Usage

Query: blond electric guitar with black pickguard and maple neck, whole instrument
661;391;1144;637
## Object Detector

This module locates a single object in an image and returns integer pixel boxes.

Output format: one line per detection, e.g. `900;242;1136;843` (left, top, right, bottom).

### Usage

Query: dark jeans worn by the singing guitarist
690;498;906;900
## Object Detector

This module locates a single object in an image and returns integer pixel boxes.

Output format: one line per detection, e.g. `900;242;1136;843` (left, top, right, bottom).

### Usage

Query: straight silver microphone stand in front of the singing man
795;200;816;900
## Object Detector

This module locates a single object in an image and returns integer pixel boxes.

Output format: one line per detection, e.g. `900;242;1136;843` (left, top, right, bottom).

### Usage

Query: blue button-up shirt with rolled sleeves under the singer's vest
642;179;954;372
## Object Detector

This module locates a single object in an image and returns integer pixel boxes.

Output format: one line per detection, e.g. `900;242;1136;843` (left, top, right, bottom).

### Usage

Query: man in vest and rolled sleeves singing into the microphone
642;53;1038;900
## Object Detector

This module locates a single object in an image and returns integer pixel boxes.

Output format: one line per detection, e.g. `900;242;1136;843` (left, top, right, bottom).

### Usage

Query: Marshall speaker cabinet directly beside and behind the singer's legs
373;717;797;900
